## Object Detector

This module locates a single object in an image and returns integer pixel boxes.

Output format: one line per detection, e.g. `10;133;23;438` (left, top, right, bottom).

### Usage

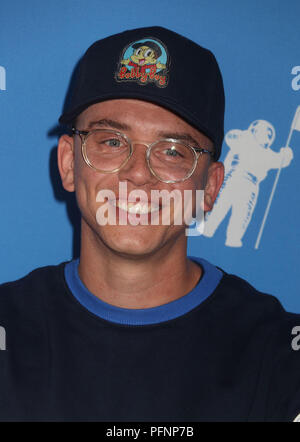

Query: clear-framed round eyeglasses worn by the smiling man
72;128;214;183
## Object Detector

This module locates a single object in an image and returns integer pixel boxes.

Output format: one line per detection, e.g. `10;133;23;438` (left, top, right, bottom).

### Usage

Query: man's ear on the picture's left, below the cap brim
57;135;75;192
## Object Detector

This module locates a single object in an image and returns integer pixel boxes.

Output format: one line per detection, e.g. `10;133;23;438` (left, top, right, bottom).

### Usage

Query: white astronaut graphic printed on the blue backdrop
203;120;293;247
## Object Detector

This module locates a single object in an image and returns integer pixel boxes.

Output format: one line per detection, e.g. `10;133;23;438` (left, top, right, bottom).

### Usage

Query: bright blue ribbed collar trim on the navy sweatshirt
65;257;223;325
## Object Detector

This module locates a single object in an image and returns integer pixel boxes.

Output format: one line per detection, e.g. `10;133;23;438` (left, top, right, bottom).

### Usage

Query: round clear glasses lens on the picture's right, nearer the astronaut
149;141;195;181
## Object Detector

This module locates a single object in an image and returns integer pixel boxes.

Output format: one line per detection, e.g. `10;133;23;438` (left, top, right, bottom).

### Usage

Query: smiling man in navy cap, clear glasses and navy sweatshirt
0;27;300;422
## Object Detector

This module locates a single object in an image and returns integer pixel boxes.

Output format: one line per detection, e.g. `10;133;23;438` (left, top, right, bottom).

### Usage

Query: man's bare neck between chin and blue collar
78;224;202;309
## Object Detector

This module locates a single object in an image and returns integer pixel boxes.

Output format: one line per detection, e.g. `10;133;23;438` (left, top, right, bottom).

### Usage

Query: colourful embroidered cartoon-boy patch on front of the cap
115;37;170;87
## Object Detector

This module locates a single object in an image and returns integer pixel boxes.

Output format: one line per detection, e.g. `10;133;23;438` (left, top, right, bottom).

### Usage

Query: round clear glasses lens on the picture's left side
86;131;130;172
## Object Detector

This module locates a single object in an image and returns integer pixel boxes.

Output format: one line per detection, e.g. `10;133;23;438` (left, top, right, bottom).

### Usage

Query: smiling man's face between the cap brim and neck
59;99;223;257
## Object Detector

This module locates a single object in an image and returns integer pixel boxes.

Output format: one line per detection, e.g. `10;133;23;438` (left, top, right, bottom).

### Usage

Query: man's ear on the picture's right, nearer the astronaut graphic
204;161;224;212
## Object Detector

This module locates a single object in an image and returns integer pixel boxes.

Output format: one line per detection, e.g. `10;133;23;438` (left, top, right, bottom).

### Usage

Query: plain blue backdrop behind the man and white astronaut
0;0;300;312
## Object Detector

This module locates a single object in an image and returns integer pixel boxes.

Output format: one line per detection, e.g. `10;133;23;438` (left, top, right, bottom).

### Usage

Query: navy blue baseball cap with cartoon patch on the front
59;26;225;160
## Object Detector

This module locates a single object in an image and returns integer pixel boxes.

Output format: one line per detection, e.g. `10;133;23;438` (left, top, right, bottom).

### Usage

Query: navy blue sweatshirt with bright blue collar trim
0;258;300;422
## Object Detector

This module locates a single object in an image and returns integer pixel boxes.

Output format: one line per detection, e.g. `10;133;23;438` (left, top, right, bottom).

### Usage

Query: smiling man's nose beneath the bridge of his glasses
119;142;157;186
